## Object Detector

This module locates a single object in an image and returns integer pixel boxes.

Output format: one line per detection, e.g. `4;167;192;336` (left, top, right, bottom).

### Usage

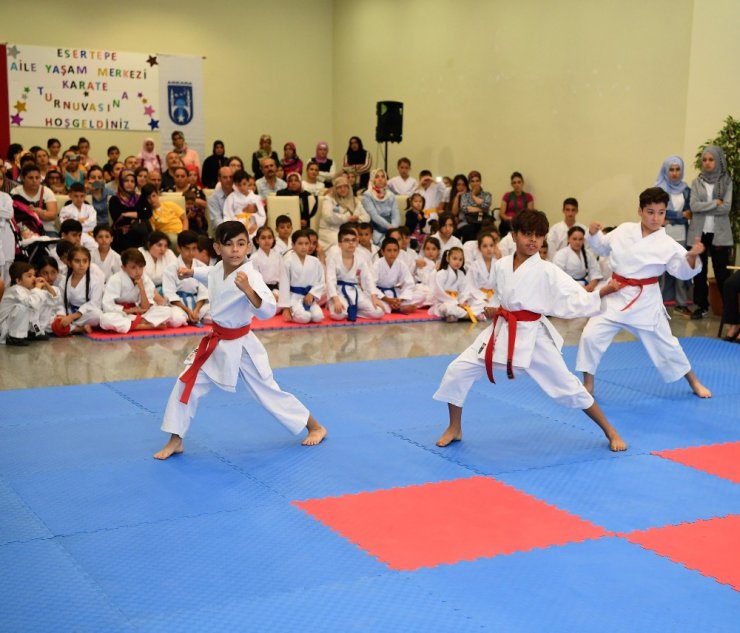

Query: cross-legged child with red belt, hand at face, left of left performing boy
100;248;187;334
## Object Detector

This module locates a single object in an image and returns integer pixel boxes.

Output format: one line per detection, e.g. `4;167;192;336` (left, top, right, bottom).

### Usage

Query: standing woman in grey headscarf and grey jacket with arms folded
687;145;733;319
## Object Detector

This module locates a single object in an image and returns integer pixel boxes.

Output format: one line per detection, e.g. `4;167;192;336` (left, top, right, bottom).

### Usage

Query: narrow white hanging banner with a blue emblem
157;55;202;161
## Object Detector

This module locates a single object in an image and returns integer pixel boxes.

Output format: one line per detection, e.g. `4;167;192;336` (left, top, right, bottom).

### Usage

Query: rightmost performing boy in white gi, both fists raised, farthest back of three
576;187;712;398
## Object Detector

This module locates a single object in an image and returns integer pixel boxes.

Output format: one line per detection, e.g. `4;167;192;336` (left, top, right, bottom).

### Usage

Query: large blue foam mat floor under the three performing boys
0;340;740;633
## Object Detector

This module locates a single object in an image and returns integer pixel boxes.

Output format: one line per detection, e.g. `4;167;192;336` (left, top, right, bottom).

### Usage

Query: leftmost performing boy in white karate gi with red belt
154;221;326;459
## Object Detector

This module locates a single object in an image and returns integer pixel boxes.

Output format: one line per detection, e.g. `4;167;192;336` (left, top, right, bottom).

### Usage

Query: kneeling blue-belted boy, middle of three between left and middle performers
326;225;385;321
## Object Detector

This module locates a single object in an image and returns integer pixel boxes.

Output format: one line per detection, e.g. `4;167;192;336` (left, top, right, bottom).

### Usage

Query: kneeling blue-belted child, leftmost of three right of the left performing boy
278;229;326;323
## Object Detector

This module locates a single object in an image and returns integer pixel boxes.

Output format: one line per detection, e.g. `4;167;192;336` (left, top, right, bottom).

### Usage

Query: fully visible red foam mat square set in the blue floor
294;477;607;571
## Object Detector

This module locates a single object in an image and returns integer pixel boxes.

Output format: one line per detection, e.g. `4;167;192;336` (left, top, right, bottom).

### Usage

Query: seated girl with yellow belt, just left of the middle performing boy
429;246;478;323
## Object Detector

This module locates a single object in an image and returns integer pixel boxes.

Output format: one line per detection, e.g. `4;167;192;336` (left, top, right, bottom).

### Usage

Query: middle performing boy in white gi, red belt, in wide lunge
434;210;627;451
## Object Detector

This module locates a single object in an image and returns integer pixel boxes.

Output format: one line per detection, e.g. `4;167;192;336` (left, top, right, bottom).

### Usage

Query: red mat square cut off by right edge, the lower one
626;515;740;591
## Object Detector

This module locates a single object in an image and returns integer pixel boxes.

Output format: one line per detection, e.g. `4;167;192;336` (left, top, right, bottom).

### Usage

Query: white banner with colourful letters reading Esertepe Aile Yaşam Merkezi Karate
7;44;159;131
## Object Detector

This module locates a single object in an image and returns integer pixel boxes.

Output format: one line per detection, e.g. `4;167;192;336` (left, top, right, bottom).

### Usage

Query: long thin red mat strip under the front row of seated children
84;310;440;341
